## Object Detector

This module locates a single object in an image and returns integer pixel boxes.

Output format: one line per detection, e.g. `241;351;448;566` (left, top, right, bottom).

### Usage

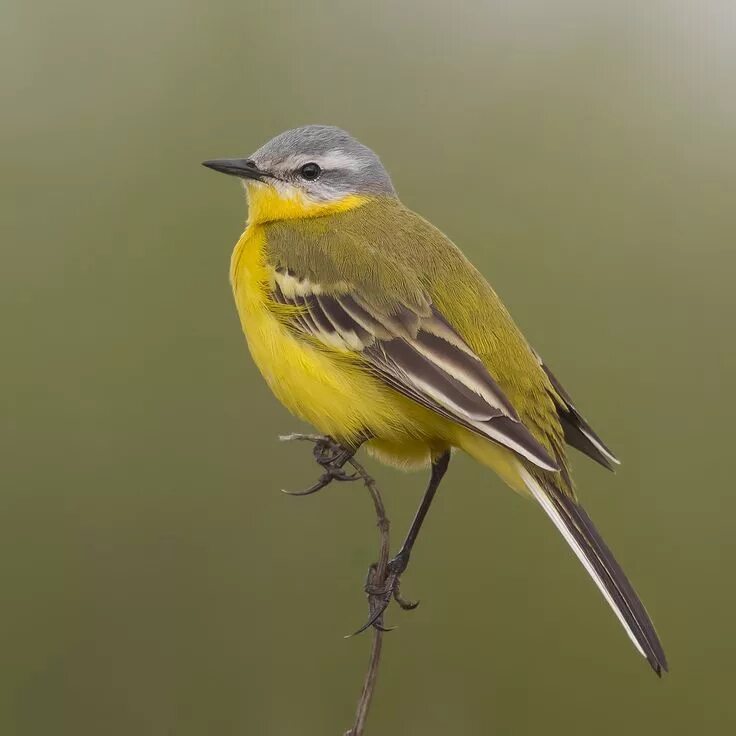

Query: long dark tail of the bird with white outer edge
521;468;667;677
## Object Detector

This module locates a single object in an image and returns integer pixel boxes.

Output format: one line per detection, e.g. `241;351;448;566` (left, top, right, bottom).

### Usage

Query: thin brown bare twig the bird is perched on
279;434;391;736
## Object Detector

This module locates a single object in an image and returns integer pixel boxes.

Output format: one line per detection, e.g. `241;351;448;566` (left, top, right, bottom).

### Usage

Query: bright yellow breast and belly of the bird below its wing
230;225;518;486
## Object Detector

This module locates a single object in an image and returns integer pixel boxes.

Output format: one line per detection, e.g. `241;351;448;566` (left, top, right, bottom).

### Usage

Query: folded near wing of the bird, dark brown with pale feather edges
273;270;559;470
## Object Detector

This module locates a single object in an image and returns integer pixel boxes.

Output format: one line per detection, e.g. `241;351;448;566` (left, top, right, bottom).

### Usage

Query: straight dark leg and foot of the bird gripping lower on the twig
355;450;450;634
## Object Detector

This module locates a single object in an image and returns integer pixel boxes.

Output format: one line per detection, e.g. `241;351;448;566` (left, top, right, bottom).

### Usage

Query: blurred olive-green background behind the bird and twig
0;0;736;736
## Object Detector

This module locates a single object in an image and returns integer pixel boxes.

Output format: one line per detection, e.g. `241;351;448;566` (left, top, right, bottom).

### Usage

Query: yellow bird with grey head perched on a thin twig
203;125;668;676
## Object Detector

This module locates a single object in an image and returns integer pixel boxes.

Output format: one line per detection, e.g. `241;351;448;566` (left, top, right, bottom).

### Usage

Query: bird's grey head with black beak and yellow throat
204;125;396;222
